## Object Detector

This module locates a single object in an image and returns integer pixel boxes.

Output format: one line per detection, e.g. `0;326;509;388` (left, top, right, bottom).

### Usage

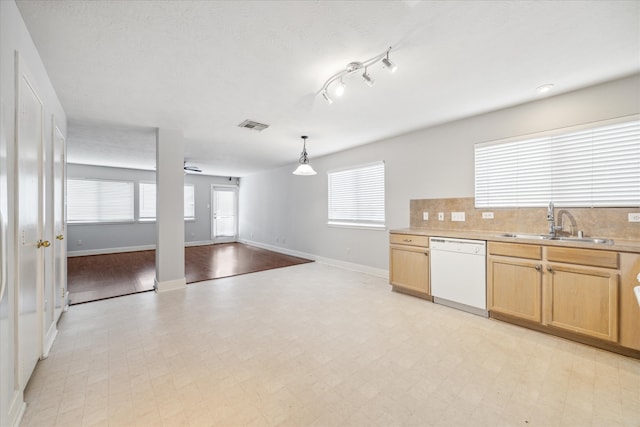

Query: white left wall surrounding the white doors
0;1;66;426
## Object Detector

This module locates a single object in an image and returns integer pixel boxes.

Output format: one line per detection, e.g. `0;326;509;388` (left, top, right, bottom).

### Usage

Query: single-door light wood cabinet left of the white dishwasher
389;234;431;298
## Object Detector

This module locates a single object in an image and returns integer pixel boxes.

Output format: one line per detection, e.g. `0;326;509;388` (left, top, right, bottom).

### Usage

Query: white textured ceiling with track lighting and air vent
17;0;640;176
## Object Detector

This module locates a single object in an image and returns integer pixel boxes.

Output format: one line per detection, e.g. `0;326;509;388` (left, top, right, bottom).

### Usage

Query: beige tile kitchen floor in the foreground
22;263;640;427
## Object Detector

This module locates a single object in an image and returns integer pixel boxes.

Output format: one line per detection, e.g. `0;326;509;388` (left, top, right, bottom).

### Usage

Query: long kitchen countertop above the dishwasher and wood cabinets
389;228;640;253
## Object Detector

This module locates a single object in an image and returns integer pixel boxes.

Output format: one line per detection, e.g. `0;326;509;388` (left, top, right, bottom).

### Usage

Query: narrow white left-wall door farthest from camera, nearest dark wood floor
52;121;67;321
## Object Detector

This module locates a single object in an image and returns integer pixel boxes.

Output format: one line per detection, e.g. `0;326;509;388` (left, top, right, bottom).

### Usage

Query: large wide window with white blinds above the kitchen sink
475;117;640;208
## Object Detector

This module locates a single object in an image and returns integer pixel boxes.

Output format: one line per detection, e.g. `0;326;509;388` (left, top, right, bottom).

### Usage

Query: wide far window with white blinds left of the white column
67;179;134;223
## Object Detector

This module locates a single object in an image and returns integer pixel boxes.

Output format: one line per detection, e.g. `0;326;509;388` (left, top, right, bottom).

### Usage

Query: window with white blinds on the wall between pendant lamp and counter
328;162;385;227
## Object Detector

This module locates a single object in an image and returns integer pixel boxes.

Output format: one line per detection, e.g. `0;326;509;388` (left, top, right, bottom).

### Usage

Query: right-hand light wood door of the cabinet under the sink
545;264;618;341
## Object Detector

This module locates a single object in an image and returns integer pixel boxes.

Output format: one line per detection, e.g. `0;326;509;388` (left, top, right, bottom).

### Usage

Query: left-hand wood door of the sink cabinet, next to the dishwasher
487;257;542;322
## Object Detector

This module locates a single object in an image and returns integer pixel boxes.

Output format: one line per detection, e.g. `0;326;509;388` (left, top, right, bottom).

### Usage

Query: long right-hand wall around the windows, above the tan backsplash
240;75;640;271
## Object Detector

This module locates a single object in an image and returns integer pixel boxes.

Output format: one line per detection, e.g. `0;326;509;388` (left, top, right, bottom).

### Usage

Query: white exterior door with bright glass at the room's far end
211;186;238;243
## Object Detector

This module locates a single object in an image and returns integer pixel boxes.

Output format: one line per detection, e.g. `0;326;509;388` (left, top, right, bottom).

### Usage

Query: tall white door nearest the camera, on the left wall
15;56;49;387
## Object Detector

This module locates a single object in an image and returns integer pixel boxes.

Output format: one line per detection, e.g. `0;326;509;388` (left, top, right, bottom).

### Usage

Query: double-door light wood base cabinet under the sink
487;242;619;342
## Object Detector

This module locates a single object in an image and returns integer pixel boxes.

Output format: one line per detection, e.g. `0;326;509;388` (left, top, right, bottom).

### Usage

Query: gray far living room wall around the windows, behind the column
67;163;236;256
